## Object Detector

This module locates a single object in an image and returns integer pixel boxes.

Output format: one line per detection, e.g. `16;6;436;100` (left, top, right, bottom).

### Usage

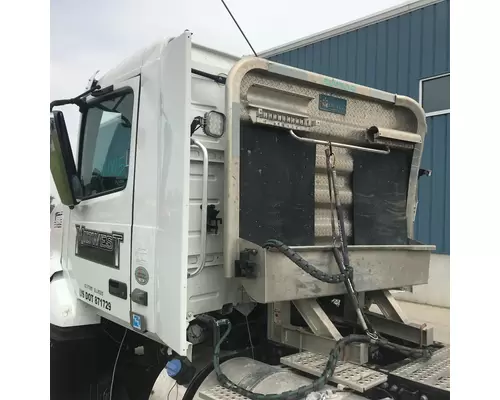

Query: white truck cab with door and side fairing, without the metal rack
51;32;237;355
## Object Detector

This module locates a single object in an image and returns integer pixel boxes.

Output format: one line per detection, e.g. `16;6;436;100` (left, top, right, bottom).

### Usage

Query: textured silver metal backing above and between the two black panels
241;72;417;244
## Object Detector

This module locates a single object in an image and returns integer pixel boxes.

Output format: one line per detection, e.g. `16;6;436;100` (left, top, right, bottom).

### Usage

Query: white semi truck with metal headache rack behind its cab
51;31;446;400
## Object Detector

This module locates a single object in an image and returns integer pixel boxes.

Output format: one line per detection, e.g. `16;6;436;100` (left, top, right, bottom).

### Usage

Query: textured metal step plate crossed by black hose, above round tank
281;351;387;393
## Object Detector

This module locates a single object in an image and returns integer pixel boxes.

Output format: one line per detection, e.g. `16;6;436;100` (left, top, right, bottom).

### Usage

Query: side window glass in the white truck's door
79;91;134;198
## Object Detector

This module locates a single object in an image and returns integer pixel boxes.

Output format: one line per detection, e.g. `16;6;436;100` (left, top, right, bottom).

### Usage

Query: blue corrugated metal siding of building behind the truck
271;0;450;254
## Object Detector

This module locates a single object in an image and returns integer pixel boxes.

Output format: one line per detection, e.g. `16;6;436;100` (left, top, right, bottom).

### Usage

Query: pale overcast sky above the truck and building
50;0;407;197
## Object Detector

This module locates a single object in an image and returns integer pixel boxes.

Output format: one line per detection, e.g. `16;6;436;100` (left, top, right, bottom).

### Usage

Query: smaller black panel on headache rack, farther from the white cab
353;149;411;245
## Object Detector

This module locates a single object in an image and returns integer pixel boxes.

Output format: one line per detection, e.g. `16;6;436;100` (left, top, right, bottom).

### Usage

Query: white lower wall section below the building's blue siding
393;254;450;308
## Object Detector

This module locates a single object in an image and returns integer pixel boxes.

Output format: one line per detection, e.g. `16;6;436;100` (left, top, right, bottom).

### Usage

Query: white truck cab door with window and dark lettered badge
67;76;140;323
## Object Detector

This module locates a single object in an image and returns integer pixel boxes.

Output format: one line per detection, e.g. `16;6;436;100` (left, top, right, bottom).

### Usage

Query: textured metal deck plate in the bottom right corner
391;347;450;392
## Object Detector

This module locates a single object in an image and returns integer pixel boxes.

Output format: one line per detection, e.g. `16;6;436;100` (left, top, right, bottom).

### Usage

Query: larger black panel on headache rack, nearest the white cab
240;123;316;246
